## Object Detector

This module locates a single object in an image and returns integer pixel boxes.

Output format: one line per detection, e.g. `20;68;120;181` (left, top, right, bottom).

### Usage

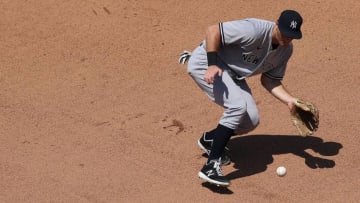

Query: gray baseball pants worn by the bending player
188;46;259;134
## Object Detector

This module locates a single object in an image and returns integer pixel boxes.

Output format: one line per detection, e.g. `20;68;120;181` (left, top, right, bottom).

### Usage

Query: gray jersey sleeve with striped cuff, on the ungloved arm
219;20;257;46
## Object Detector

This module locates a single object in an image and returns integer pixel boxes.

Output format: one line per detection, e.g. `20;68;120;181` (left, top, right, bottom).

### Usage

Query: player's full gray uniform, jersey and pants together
188;18;293;134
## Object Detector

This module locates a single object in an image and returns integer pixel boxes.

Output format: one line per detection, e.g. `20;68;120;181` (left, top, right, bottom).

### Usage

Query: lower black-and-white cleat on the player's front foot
198;157;230;187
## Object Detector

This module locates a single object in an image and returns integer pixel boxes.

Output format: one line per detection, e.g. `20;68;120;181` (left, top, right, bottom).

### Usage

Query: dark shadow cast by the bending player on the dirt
226;135;343;180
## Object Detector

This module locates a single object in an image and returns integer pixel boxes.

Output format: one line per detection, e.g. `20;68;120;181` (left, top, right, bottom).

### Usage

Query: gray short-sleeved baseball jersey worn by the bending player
202;18;293;80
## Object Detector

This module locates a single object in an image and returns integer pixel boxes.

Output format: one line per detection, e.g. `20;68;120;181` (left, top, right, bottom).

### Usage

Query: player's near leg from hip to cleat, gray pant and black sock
188;47;257;186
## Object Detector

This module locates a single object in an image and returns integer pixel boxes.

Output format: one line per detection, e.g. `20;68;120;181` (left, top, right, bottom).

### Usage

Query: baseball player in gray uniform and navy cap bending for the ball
179;10;303;186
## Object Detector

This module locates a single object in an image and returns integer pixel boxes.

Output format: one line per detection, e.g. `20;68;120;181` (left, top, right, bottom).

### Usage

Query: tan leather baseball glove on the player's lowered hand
290;99;319;136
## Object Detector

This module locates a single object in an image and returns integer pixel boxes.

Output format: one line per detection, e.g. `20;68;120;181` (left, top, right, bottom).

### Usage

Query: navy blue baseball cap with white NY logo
278;10;303;39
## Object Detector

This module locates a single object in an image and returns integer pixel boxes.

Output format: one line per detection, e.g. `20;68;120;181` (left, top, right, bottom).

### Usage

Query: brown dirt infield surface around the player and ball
0;0;360;202
